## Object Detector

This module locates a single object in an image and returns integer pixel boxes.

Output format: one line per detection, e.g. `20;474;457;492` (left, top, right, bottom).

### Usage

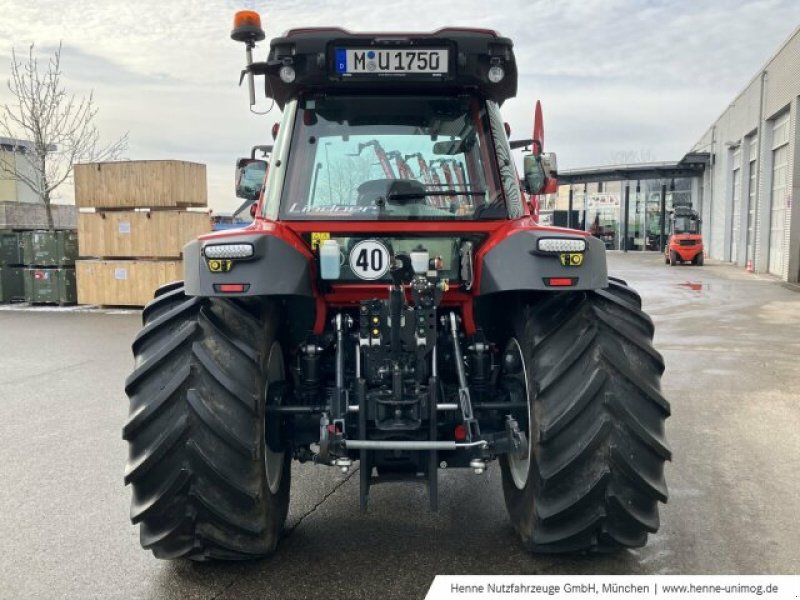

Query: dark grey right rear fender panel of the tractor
480;230;608;295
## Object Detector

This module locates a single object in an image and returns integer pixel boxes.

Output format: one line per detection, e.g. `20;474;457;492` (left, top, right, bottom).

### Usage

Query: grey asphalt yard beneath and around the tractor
0;253;800;600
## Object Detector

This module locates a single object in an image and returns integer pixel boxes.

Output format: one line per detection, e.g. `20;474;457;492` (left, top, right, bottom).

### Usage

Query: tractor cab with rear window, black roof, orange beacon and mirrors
225;18;556;229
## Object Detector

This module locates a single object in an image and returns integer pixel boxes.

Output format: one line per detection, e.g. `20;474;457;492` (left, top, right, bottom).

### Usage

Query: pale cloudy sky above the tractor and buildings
0;0;800;211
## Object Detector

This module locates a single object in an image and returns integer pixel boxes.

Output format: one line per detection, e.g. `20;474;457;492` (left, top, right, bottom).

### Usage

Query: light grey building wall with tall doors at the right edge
693;27;800;282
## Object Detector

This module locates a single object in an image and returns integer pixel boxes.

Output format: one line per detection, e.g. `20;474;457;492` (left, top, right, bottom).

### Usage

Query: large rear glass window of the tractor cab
281;96;507;220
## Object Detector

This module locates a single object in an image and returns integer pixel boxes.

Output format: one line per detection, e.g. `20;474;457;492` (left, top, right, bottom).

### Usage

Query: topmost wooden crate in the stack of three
75;160;208;208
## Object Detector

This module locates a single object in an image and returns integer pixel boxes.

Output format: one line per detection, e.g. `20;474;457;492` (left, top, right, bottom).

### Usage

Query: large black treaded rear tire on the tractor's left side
123;284;291;560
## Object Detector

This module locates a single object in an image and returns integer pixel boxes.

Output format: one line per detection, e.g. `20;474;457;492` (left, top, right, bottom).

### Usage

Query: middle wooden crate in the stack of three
78;210;211;258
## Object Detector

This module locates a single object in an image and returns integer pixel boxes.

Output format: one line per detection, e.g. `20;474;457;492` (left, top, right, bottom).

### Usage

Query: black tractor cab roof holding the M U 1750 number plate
248;27;517;108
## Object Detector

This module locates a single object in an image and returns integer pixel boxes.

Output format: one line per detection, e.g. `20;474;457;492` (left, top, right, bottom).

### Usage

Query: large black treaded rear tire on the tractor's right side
500;279;671;553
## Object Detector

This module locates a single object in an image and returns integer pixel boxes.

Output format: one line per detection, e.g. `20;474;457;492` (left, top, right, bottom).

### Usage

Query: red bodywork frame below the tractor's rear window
200;215;588;335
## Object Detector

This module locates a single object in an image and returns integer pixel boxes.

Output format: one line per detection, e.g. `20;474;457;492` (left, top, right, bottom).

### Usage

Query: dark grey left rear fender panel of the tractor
183;233;313;296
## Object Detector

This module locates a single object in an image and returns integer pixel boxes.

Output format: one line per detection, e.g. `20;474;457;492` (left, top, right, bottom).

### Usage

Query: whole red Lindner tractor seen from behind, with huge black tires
124;11;670;560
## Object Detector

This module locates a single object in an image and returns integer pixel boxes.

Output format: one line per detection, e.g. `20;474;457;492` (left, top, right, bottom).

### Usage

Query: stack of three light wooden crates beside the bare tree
75;160;211;306
